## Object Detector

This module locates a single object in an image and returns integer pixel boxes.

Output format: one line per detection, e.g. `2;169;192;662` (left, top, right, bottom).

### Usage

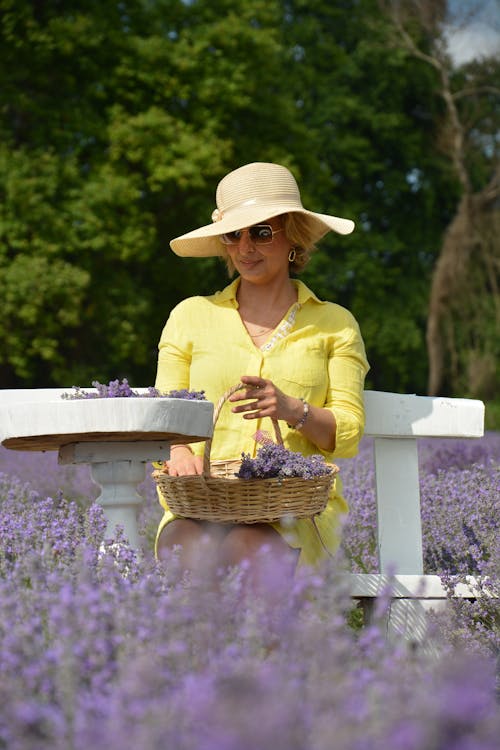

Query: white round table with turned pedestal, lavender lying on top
0;396;213;547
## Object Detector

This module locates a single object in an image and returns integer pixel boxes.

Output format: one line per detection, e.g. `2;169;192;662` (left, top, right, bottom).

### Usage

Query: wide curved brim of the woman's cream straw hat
170;203;354;258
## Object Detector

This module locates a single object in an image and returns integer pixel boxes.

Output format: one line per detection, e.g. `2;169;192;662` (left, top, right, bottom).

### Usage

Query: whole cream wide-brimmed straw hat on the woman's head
170;162;354;257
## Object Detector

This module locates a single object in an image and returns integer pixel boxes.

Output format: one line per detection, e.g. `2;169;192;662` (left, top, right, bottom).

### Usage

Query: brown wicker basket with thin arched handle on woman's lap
153;383;338;524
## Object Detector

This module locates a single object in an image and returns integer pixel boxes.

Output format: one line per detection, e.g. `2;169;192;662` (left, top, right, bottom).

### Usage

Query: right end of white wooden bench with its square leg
349;391;484;651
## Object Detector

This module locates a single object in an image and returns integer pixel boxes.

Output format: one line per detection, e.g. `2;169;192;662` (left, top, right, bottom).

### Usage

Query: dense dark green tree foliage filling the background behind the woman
0;0;498;402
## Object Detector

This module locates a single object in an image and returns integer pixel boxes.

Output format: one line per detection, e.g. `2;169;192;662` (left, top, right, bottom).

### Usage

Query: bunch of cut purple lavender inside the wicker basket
236;443;332;479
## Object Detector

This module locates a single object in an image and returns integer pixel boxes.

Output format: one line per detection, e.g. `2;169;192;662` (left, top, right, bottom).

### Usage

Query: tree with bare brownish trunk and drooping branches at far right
382;0;500;398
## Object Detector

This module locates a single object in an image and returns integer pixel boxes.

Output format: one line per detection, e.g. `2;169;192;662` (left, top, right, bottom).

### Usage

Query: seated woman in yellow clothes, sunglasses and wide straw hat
156;163;368;580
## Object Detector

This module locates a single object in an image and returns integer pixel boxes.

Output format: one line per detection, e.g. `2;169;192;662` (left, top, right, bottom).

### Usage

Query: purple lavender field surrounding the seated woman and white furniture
0;433;500;750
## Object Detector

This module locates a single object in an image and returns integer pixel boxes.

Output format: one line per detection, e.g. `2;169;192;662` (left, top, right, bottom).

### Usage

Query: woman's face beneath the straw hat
222;216;291;284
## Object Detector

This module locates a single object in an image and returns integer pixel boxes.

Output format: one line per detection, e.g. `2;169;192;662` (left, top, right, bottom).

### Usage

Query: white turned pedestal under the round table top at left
59;441;170;549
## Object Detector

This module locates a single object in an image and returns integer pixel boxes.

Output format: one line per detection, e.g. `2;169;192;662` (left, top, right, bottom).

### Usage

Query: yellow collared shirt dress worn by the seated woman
156;278;368;564
